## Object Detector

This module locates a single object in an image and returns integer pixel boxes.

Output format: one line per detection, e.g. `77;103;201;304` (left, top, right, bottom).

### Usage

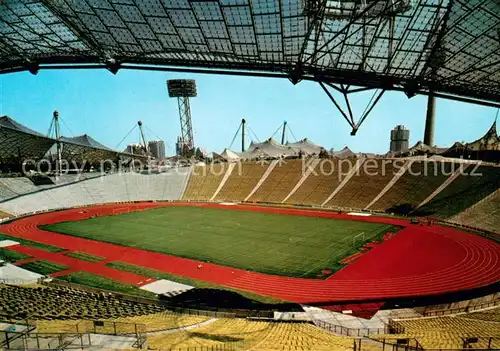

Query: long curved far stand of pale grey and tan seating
0;159;500;231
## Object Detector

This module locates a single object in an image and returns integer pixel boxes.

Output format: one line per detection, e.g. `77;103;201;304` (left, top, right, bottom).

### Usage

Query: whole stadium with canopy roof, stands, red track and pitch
0;0;500;351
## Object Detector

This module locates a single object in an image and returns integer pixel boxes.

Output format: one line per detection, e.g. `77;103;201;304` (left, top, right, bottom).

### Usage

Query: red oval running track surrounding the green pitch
0;203;500;303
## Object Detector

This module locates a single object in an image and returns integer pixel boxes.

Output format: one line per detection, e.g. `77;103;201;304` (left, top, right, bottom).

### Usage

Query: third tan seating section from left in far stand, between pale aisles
248;160;302;203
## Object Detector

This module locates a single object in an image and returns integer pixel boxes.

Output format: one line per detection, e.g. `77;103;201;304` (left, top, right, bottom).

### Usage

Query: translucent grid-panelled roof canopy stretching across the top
0;0;500;106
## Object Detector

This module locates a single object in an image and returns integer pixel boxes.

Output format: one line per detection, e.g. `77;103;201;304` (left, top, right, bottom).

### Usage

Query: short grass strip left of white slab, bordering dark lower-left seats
57;272;156;299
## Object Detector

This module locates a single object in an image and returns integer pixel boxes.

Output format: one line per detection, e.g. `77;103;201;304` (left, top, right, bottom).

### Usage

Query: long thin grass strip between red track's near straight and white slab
105;262;283;304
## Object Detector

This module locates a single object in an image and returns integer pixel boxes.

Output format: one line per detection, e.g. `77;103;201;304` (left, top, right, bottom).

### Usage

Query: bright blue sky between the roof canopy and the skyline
0;70;497;154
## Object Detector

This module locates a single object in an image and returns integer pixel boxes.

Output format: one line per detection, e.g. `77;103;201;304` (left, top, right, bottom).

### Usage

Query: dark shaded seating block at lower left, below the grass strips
0;284;162;320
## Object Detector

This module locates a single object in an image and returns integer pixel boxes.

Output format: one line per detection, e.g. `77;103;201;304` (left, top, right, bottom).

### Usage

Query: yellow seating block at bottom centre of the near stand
148;319;353;351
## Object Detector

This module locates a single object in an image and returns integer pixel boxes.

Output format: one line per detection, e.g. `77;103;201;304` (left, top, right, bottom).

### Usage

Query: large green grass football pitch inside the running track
41;206;395;277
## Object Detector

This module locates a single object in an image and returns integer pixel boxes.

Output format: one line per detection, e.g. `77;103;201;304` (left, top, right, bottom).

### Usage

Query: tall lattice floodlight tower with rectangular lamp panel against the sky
167;79;197;156
